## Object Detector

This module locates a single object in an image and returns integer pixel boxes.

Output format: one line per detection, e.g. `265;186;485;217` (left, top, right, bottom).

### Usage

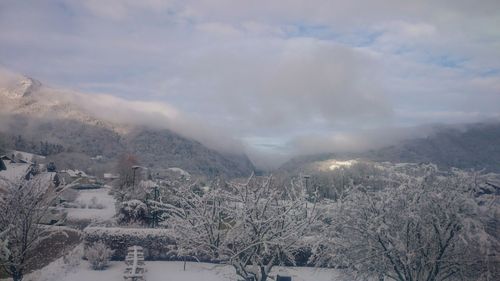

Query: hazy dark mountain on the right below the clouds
280;123;500;172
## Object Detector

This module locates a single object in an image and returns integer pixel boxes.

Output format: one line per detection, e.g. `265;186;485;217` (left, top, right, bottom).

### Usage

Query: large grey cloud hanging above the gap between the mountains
173;36;391;134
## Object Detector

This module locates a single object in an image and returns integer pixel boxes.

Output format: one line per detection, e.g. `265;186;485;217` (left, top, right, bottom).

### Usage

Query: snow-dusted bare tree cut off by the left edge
0;177;65;281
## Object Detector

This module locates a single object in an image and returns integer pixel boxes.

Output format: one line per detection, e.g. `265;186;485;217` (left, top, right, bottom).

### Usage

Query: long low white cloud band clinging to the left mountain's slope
0;67;244;154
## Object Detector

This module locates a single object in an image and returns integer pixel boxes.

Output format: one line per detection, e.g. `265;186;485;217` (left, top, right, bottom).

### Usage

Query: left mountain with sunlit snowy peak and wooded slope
0;77;254;177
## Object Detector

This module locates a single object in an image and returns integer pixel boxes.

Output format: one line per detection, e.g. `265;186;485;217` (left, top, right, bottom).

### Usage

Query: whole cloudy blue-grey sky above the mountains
0;0;500;165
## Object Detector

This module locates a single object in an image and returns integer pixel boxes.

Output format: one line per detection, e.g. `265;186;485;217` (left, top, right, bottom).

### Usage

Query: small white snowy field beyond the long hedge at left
67;187;115;221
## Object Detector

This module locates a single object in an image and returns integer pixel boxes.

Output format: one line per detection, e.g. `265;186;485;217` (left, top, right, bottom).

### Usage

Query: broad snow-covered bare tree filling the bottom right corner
316;166;495;281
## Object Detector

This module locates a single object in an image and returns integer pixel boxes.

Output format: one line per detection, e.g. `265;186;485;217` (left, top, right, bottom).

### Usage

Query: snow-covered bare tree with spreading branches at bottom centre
169;177;316;281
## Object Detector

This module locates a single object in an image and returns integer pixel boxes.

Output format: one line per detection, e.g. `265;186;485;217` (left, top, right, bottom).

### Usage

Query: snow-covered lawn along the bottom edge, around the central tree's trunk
19;260;343;281
